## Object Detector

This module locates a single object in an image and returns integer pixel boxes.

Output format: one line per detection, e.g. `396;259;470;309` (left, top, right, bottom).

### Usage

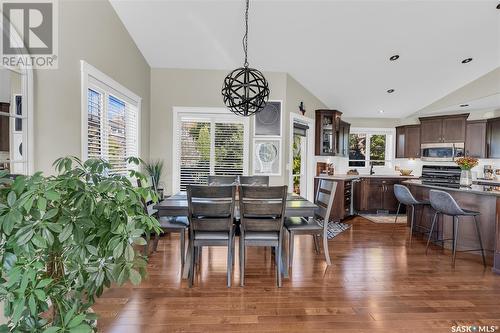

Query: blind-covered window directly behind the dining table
174;111;248;191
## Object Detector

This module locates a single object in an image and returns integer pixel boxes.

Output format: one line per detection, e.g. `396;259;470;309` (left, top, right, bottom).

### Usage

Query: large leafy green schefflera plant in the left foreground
0;157;160;333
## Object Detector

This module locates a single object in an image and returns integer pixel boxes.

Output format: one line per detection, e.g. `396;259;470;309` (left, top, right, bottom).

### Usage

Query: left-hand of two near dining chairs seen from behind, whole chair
187;185;236;288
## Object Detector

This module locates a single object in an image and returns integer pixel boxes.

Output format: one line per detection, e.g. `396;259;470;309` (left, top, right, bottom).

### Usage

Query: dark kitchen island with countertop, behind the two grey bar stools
403;179;500;274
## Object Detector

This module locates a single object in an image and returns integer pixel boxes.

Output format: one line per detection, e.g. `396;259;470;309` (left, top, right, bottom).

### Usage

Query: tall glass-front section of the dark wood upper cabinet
315;110;342;156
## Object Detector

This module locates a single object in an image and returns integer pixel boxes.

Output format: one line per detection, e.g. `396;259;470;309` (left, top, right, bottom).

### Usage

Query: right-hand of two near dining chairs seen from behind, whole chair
239;186;288;287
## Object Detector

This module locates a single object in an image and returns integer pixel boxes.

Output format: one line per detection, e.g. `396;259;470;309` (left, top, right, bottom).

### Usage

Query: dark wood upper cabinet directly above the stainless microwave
419;113;469;144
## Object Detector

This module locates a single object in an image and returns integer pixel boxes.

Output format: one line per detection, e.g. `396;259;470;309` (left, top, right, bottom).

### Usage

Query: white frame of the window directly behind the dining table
172;107;250;193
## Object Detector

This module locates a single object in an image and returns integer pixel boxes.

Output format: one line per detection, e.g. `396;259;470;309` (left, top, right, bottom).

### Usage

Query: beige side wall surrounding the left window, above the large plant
34;0;150;172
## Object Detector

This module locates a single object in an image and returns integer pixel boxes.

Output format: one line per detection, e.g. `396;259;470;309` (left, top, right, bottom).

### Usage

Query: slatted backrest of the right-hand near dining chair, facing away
239;185;288;232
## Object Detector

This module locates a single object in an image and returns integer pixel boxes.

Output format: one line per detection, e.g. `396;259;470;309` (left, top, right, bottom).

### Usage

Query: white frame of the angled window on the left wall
80;60;142;165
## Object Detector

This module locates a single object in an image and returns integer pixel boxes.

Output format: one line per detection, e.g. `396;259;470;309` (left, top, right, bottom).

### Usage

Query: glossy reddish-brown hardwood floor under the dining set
94;217;500;333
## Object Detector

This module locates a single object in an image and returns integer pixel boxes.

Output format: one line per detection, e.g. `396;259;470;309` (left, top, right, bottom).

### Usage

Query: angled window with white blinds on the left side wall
82;62;140;174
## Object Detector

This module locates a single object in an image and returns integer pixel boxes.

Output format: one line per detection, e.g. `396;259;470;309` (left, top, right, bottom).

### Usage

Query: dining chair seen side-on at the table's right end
285;179;337;268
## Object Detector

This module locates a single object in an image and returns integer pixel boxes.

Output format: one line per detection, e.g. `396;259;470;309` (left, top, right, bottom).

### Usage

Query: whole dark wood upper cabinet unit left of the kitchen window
315;109;350;156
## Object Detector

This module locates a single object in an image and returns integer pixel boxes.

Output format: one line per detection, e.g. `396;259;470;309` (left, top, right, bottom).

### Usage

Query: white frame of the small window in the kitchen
347;127;396;169
